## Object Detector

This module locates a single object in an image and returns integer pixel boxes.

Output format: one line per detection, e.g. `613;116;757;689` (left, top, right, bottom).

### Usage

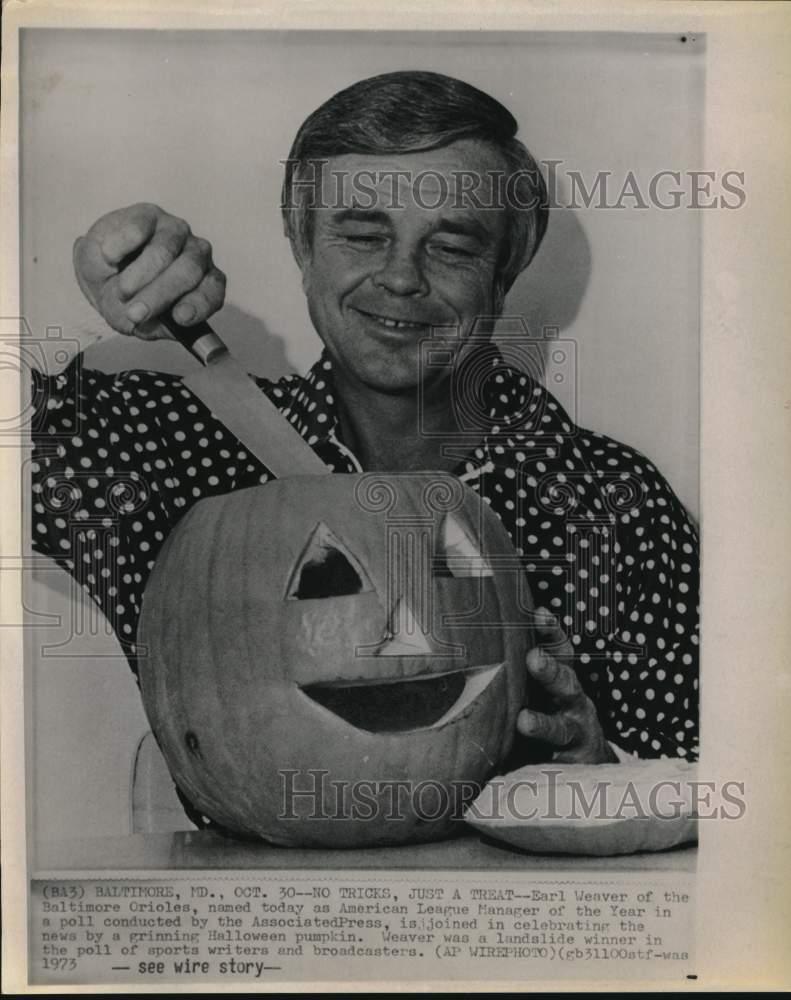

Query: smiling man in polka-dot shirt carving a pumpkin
34;72;697;804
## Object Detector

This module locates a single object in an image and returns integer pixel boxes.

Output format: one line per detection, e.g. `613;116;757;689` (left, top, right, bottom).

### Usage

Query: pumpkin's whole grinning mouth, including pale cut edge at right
300;664;502;733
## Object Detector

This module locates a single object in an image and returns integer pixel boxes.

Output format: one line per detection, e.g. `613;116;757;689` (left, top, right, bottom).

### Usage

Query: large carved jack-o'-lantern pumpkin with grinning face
138;473;532;847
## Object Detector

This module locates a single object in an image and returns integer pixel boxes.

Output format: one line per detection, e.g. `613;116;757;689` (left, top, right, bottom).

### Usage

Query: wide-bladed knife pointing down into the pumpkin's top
165;316;330;479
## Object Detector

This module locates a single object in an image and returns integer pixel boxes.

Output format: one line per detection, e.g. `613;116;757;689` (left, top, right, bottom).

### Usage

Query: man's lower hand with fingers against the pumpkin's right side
516;608;618;764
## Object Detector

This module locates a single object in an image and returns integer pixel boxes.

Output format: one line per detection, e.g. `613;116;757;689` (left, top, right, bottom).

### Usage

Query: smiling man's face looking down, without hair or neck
302;140;506;393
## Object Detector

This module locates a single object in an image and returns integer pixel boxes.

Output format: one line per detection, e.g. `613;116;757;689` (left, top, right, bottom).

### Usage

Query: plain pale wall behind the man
21;29;703;838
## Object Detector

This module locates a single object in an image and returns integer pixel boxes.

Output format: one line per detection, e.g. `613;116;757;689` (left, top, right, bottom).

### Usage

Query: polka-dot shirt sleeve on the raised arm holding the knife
31;355;268;669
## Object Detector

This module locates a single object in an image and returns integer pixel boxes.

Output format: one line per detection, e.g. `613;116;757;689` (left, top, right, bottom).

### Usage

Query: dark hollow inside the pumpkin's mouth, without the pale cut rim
302;671;465;733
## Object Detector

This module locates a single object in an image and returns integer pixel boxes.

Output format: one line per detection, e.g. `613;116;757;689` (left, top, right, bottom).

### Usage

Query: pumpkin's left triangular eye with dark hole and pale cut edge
287;521;373;601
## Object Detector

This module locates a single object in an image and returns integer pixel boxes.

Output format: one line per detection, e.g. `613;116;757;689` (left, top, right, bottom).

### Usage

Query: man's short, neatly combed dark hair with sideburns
282;70;549;294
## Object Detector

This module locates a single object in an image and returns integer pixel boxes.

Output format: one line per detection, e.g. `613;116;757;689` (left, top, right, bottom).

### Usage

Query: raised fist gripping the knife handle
74;203;225;340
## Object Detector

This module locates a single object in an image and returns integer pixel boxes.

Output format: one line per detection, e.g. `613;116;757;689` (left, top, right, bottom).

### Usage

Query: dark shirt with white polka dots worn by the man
33;349;698;760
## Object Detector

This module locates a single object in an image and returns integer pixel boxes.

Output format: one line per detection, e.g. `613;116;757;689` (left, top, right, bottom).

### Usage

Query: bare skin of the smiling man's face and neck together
296;139;507;469
